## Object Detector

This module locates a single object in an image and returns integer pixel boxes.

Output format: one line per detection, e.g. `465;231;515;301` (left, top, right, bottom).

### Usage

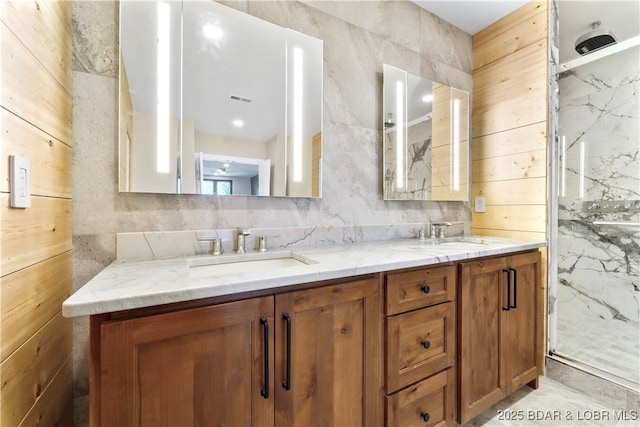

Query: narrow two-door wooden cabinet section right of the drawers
458;251;544;424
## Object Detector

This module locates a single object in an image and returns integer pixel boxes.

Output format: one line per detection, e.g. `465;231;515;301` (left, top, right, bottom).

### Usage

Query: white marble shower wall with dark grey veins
558;47;640;352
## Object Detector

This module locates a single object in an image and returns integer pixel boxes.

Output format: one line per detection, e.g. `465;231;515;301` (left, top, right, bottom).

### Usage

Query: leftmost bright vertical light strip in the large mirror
156;2;171;173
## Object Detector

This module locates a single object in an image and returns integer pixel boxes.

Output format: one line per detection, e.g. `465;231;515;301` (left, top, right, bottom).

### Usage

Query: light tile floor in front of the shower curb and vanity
463;377;640;427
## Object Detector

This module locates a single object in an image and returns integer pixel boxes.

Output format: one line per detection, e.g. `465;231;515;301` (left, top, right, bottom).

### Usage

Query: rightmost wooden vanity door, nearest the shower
504;252;544;393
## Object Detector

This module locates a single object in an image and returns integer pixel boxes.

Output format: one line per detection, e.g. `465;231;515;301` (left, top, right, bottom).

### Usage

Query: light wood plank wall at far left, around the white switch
0;1;73;426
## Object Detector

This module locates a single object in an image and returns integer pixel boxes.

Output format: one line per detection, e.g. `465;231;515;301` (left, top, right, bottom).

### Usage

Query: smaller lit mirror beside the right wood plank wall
382;64;470;201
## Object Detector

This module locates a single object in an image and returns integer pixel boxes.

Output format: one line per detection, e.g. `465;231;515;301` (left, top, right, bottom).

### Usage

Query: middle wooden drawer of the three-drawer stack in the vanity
386;302;456;393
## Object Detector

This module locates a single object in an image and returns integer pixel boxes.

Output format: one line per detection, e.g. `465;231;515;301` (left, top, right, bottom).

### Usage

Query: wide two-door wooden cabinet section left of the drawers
90;276;382;427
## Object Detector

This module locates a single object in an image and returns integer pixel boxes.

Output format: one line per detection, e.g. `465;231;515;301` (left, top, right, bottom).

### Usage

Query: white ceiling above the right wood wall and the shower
413;0;640;63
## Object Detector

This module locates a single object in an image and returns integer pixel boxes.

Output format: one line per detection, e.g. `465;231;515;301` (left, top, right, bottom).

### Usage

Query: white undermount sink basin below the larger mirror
187;251;317;277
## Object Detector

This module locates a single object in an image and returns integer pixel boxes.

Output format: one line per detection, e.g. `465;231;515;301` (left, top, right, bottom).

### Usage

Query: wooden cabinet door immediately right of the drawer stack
458;258;507;424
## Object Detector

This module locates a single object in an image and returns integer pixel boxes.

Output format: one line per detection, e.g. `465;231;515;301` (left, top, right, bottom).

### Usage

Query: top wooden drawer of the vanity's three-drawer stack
385;265;456;316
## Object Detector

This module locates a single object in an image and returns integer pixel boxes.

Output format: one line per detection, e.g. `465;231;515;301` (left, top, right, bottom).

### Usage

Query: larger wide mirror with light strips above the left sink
119;0;323;197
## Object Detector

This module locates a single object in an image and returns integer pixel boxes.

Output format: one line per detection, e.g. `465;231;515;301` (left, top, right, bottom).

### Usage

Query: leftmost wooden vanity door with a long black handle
92;297;274;427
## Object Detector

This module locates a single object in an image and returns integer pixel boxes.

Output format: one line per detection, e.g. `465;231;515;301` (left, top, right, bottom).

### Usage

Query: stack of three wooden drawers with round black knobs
385;264;456;427
